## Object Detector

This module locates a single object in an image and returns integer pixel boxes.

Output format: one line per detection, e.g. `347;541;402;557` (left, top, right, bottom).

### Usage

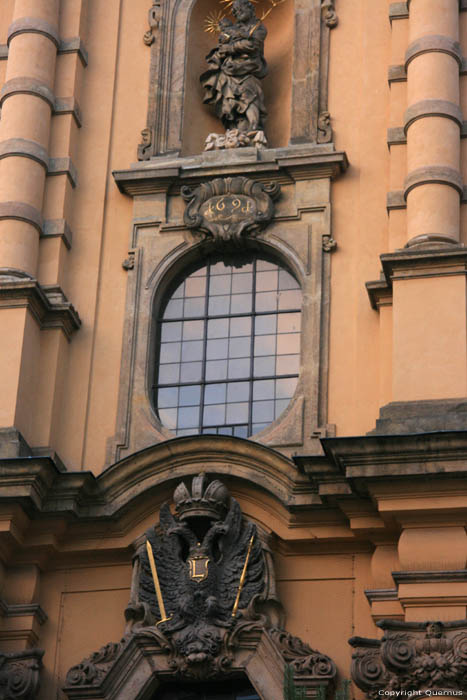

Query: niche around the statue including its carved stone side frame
138;0;337;160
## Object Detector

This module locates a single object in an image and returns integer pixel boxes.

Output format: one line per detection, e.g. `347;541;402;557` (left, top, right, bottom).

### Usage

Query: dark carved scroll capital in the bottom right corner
349;620;467;700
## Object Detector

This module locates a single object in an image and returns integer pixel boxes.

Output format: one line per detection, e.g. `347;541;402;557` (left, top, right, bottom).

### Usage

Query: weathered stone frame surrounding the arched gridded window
106;197;334;464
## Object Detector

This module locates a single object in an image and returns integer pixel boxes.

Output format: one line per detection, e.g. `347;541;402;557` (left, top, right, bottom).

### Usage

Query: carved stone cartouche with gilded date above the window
181;176;280;243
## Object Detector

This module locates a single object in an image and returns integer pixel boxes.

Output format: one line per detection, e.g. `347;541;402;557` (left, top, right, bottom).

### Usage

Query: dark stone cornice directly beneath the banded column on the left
0;277;81;340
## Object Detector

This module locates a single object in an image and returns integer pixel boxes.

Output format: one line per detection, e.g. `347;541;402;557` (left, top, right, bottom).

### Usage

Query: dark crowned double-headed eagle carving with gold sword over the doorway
64;474;336;700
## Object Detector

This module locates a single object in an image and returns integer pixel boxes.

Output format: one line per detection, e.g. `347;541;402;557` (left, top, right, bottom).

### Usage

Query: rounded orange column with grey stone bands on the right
404;0;462;246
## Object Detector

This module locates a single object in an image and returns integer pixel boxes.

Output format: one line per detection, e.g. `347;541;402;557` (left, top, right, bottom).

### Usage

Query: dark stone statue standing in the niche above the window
200;0;267;150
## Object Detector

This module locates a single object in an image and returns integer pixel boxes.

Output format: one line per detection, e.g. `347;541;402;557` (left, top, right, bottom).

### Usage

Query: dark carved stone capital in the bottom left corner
0;649;44;700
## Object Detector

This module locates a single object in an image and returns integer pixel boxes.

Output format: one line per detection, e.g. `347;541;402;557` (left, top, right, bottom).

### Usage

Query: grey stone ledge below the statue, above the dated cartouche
113;144;348;197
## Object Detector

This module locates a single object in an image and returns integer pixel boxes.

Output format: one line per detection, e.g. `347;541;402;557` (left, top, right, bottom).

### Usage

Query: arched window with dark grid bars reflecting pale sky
154;255;302;437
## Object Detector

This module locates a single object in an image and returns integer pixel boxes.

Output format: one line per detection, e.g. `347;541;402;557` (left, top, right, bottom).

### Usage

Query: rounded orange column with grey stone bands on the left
0;0;59;277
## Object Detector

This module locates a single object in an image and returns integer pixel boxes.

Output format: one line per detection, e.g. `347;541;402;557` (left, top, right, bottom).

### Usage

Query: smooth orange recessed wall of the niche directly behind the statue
181;0;294;156
